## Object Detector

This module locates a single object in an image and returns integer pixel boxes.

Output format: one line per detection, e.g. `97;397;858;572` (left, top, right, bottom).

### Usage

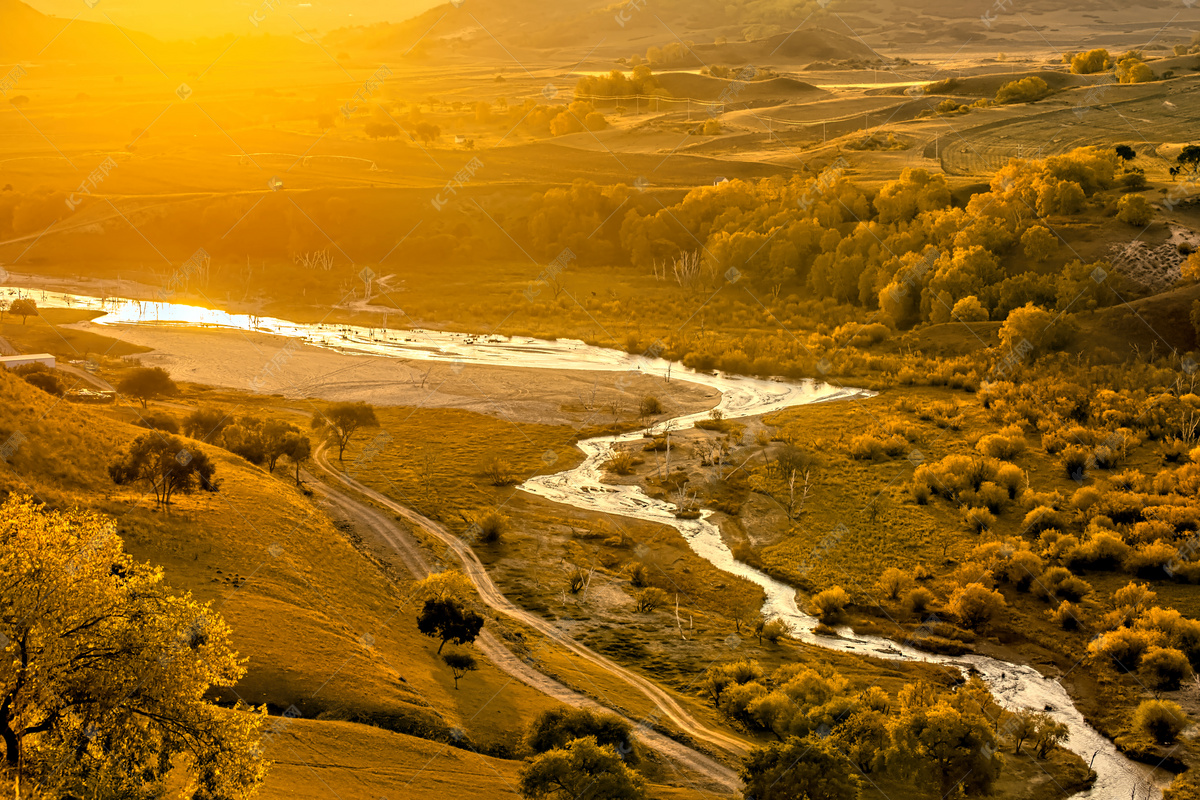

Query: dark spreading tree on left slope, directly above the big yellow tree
108;433;217;506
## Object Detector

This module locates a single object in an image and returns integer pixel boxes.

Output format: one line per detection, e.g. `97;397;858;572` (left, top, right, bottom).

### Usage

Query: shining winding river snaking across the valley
7;288;1160;800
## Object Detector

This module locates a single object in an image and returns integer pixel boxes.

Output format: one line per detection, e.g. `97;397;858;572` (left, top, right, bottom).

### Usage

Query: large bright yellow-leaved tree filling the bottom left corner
0;497;265;798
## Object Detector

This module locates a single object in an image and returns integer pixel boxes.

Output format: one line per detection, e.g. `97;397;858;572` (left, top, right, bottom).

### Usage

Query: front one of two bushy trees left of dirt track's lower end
521;736;646;800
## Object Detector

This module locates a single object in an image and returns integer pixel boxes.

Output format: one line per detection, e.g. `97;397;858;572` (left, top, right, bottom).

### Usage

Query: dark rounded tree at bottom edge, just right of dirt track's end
738;734;860;800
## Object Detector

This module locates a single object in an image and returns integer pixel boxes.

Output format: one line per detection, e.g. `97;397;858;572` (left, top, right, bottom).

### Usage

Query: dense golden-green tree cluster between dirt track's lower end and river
706;661;1027;798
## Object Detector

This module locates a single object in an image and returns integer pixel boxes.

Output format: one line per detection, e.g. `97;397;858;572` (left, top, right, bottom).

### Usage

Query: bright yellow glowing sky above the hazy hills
26;0;439;38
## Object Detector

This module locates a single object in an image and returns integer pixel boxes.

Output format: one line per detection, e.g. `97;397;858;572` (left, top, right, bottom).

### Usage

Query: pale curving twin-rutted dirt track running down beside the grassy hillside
304;445;748;792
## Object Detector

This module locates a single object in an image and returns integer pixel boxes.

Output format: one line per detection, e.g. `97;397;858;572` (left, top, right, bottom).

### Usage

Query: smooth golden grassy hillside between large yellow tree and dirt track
0;372;561;786
